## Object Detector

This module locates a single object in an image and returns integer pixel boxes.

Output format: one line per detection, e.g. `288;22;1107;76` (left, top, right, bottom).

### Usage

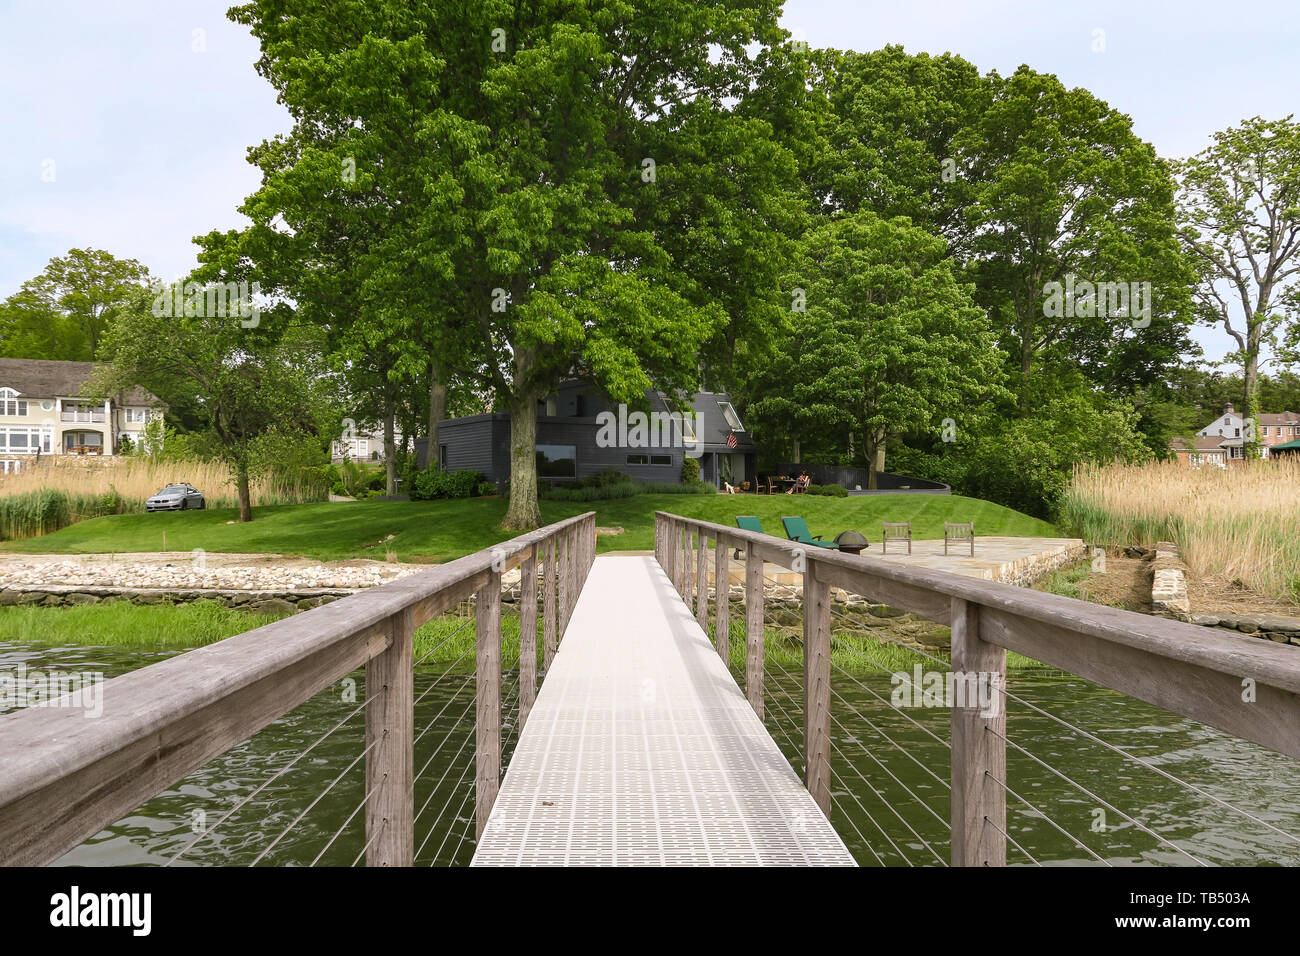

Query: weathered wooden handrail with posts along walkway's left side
0;511;595;865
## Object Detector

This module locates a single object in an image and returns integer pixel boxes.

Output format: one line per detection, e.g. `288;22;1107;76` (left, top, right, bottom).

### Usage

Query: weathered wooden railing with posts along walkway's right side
655;511;1300;866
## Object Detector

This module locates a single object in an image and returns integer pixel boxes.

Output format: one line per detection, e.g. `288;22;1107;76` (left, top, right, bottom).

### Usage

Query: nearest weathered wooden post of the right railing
952;598;1006;866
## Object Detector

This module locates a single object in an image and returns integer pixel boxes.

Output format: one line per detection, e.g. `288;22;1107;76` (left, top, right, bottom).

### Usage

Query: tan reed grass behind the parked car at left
0;458;329;540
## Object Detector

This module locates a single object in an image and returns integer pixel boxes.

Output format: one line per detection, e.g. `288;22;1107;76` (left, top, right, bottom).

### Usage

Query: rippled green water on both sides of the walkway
0;643;1300;866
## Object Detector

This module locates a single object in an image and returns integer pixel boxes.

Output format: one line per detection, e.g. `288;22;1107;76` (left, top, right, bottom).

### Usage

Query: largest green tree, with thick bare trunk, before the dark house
233;0;784;529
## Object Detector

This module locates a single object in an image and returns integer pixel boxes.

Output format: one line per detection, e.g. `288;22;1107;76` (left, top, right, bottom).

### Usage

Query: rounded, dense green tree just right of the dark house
753;212;1006;486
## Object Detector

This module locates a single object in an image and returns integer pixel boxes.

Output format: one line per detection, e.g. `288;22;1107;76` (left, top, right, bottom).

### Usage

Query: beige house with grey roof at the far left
0;359;163;473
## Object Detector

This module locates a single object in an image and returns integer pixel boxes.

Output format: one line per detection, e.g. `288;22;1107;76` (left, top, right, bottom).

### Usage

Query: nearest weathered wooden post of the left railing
365;607;415;866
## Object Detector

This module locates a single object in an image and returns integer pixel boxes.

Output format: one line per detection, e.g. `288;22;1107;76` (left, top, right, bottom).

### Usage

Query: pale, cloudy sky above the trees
0;0;1300;358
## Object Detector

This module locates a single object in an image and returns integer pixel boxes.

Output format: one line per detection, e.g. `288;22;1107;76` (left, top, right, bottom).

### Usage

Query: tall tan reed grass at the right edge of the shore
1060;458;1300;601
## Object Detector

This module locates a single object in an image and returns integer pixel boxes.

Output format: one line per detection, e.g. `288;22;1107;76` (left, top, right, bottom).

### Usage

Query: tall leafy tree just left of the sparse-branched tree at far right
958;66;1192;411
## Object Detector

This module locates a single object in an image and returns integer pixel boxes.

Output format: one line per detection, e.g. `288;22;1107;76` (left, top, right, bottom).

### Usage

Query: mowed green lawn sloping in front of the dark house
0;494;1058;562
